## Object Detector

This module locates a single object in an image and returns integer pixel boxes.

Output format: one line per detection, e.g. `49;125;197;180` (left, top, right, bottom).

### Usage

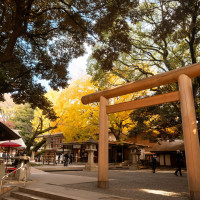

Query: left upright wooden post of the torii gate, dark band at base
98;96;108;188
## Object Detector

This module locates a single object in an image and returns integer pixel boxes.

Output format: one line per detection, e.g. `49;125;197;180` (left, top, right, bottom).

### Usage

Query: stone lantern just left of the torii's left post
84;136;97;171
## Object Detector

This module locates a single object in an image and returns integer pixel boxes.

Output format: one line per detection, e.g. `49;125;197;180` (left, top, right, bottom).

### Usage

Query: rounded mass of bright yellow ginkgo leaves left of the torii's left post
54;77;99;142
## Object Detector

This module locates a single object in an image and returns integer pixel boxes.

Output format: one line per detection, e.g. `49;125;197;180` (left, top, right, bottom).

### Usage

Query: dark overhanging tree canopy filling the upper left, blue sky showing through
0;0;137;119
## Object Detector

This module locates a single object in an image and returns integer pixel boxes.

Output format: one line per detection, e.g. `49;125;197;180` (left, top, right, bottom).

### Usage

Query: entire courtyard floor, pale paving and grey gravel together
26;165;189;200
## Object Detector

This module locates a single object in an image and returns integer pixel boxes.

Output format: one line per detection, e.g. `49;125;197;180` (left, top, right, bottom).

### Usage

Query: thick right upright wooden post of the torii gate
178;74;200;200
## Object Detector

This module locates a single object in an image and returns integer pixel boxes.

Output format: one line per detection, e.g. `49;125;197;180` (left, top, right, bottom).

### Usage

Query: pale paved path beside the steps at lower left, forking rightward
26;167;117;200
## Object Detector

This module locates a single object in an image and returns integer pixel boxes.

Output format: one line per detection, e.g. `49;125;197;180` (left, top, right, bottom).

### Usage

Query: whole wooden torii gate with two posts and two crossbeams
81;63;200;200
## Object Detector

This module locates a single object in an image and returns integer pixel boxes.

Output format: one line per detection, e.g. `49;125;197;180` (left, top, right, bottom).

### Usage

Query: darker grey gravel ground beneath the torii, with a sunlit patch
48;170;189;200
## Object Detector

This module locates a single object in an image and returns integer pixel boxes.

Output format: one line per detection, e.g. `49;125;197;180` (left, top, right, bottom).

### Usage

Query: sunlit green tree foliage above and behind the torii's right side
88;0;200;138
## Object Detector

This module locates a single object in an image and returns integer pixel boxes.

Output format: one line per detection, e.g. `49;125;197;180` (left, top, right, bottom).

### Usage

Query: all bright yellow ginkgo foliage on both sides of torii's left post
32;77;142;142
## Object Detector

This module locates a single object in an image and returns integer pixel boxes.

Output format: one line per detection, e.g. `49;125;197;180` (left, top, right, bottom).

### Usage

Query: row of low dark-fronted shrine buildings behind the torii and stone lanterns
36;133;184;167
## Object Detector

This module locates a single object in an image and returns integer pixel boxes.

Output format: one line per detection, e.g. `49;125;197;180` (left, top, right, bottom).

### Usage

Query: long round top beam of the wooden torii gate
81;63;200;104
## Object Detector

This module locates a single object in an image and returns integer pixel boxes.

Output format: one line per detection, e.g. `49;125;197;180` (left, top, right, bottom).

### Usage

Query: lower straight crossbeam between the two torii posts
106;91;180;114
